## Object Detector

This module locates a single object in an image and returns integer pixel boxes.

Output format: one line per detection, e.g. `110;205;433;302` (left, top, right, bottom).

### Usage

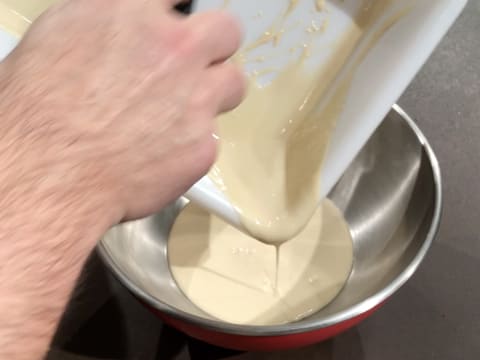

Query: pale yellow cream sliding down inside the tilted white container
210;0;398;244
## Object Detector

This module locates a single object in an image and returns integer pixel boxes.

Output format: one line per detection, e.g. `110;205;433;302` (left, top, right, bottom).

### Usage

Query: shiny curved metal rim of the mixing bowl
97;104;443;337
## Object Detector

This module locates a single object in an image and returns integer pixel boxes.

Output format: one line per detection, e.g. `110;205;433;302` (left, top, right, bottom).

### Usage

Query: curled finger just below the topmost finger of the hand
205;62;247;114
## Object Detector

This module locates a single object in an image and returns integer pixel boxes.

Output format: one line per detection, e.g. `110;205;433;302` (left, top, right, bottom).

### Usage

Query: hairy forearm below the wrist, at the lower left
0;139;119;360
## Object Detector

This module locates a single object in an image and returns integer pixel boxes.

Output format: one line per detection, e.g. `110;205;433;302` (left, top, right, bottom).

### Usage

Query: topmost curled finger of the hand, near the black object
185;11;242;64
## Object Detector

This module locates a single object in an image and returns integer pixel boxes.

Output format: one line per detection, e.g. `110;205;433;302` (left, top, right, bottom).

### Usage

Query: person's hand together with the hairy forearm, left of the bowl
0;0;245;360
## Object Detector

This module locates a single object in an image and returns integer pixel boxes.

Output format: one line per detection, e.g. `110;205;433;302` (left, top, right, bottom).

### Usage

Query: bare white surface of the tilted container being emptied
187;0;467;228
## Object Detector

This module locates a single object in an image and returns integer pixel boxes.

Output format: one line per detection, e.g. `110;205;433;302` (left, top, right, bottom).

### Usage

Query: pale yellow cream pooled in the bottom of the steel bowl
168;201;353;325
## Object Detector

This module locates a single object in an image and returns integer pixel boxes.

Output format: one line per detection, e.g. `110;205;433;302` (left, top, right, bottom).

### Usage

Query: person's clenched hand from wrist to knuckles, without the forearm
0;0;245;220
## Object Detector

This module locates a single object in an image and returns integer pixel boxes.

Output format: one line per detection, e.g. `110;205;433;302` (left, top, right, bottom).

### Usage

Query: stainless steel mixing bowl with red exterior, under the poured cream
99;106;442;350
